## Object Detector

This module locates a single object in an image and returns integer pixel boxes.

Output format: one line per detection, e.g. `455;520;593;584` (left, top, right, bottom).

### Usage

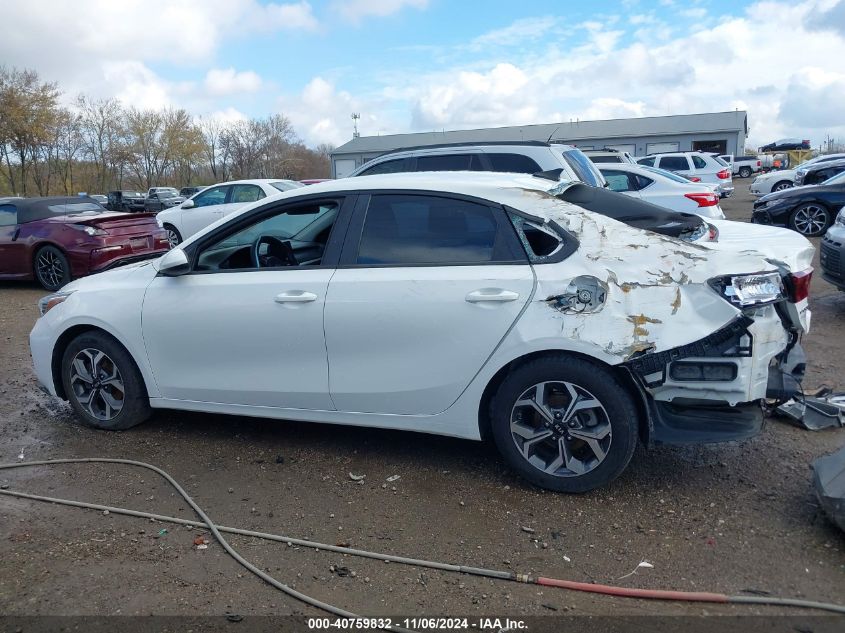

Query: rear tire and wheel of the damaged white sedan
490;356;638;493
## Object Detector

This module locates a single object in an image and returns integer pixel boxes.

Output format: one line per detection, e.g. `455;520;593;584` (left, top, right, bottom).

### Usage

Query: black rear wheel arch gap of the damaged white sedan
478;349;651;445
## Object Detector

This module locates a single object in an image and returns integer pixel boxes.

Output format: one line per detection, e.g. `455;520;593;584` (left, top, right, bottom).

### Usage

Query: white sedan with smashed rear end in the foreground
30;172;813;492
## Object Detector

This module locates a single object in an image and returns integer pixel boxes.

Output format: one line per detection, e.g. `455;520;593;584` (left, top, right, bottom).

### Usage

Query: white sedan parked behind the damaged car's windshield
156;178;303;247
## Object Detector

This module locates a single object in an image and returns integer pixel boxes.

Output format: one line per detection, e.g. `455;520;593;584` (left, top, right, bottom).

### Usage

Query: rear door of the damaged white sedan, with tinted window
325;193;534;415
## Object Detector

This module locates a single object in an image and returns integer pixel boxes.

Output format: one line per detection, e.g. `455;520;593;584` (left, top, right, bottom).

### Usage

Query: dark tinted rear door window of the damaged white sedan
357;195;516;265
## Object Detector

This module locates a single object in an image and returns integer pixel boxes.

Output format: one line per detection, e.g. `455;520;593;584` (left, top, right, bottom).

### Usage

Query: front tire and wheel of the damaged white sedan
61;332;152;431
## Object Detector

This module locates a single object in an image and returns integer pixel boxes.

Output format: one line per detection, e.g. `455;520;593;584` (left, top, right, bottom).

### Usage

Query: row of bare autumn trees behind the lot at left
0;66;333;196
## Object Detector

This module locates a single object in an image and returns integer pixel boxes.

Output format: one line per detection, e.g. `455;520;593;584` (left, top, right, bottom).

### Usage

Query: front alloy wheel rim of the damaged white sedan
70;348;126;421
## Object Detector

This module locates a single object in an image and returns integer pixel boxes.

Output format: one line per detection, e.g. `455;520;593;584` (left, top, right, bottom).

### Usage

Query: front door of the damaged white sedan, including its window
142;198;348;410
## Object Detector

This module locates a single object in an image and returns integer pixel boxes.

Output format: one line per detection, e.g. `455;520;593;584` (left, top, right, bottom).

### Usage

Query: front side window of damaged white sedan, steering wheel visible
196;202;338;272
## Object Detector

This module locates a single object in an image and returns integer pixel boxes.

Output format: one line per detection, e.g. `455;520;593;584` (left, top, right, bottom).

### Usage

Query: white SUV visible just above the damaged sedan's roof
350;141;607;187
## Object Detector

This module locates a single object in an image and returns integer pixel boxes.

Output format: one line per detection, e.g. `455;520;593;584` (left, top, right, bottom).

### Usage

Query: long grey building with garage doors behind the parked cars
332;110;748;178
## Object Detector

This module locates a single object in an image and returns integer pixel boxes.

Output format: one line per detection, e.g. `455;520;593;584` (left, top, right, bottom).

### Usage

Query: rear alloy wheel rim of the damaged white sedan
510;382;612;477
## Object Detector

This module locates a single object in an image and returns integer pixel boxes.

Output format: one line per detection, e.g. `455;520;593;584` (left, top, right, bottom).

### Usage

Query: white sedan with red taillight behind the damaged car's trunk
598;163;725;218
